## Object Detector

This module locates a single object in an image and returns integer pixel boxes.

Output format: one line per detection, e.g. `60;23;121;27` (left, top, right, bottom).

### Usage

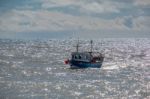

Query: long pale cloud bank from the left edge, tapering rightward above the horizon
0;10;129;32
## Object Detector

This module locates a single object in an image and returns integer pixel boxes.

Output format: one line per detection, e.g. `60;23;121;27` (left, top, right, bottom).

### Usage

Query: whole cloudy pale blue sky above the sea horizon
0;0;150;39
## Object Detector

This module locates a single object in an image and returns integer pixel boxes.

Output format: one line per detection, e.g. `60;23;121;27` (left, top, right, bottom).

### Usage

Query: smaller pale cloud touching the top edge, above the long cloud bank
41;0;119;13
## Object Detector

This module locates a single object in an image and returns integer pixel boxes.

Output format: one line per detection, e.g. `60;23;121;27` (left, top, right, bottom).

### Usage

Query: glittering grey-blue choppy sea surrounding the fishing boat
0;38;150;99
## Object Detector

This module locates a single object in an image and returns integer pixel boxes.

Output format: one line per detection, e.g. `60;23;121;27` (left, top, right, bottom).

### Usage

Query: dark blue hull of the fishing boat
70;61;102;68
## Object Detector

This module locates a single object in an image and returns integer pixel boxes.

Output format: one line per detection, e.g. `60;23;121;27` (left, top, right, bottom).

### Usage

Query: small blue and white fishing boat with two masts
64;40;104;68
